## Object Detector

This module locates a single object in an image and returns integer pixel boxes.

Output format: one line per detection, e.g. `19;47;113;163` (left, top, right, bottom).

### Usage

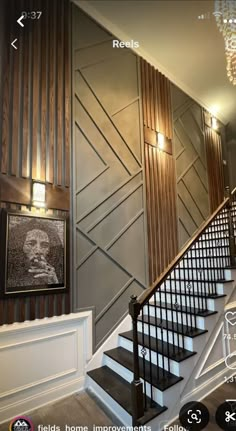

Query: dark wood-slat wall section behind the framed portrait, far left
0;0;71;324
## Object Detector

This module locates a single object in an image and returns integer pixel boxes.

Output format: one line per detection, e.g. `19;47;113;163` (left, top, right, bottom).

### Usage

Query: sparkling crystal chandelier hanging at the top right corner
213;0;236;85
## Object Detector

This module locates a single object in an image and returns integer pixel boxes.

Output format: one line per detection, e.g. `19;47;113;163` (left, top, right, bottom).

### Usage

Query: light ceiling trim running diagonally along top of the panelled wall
73;0;228;125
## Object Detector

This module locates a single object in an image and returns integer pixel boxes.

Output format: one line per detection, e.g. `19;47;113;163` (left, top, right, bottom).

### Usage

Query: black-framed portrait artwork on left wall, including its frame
0;210;68;296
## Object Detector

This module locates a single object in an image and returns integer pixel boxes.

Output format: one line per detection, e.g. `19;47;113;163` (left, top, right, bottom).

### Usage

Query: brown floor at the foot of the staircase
0;383;236;431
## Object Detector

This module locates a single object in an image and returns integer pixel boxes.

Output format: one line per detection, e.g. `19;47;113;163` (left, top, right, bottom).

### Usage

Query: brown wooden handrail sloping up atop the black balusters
137;197;229;309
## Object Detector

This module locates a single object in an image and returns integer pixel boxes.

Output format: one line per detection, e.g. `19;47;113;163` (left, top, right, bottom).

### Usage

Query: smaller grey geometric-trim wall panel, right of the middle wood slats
171;85;209;247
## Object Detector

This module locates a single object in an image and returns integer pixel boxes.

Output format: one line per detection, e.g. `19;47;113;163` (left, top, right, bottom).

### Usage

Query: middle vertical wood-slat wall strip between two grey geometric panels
141;60;178;283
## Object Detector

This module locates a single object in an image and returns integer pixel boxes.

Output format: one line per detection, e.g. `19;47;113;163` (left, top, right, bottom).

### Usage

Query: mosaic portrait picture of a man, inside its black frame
5;214;65;293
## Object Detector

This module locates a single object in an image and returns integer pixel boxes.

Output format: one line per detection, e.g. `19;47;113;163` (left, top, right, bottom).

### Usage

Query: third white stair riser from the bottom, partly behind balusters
119;337;194;377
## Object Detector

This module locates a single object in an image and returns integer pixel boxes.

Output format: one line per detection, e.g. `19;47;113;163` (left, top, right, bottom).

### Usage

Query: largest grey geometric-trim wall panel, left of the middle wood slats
73;6;147;348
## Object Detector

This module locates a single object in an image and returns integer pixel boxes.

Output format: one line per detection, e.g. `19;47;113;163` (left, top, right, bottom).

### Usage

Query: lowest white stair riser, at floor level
87;376;132;427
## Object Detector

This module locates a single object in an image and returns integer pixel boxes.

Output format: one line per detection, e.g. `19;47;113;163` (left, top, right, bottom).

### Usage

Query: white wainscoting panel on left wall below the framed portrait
0;311;92;423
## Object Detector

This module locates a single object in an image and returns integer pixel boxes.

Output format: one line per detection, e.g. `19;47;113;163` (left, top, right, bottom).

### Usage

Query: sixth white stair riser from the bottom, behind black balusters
153;292;219;311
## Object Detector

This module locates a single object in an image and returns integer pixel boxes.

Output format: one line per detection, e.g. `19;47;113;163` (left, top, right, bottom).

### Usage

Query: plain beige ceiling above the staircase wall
75;0;236;128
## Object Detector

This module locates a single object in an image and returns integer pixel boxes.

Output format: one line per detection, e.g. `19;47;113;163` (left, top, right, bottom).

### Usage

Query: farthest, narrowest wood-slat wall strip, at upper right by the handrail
205;125;224;212
